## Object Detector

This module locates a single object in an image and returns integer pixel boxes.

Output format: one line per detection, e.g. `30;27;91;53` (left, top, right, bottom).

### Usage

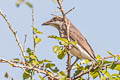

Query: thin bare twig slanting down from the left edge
0;10;25;59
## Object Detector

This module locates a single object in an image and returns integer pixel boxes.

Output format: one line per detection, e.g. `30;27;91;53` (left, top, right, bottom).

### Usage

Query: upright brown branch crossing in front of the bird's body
57;0;71;79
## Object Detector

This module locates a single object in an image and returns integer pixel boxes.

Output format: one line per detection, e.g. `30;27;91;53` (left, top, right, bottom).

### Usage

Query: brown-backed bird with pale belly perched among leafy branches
42;16;98;64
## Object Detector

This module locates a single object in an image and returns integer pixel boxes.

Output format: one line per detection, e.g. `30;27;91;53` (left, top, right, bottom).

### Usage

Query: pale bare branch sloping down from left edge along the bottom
0;59;59;80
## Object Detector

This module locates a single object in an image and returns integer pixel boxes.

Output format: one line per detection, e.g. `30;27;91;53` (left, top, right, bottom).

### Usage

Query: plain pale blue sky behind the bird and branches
0;0;120;80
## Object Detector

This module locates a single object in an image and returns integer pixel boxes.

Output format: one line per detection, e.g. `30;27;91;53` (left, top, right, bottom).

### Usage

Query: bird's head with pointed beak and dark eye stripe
42;16;64;29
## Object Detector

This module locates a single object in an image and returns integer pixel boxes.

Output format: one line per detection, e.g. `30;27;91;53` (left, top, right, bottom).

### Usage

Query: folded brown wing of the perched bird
70;24;95;59
